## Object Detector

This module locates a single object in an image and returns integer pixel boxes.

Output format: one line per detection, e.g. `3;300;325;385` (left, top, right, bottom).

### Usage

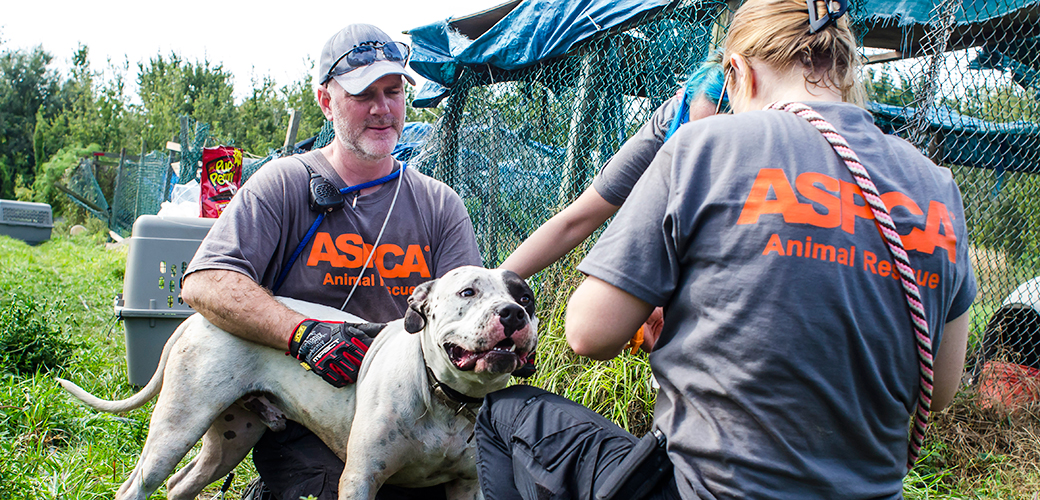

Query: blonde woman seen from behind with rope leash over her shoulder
476;0;976;499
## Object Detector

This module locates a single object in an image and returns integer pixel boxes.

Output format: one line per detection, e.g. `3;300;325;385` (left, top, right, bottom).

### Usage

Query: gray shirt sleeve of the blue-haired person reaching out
592;96;682;207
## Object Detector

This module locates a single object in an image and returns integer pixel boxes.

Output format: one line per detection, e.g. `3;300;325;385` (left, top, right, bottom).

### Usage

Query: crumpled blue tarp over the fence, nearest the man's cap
409;0;669;103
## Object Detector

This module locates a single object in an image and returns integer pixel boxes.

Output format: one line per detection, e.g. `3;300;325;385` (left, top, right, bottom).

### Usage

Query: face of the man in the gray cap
327;75;405;161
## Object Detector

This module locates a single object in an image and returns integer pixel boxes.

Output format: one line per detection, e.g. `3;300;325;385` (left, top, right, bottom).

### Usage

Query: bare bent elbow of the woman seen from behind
565;277;656;360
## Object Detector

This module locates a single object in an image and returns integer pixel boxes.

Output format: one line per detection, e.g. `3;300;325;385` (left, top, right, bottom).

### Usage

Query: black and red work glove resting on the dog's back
289;319;386;387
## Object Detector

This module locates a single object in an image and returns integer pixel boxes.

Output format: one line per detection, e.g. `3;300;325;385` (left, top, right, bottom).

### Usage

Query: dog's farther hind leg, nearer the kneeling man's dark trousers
166;404;267;500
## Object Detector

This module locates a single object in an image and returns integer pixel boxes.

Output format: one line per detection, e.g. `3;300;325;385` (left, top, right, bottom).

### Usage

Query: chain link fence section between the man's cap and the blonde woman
413;2;729;267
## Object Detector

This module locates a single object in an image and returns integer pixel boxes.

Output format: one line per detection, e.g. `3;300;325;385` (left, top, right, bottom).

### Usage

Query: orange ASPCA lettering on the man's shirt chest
307;233;432;279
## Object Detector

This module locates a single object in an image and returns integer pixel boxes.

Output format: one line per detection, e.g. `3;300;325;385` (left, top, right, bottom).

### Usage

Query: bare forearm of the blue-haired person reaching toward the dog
498;186;619;278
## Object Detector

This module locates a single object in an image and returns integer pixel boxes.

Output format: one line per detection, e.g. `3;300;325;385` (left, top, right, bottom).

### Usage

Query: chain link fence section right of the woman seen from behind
861;0;1040;392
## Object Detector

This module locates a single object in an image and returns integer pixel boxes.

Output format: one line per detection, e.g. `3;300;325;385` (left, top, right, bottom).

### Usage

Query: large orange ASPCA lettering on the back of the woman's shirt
736;168;957;263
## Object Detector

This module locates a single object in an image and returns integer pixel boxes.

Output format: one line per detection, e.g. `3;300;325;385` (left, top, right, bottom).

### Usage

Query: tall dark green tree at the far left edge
0;46;59;198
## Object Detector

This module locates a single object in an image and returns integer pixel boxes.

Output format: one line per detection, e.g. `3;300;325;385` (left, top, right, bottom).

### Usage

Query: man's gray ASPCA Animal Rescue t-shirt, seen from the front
187;151;482;322
